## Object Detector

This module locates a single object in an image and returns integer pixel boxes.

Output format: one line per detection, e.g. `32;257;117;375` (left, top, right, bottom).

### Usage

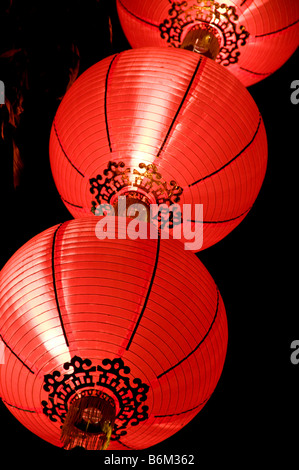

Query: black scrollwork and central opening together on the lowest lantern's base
42;356;149;450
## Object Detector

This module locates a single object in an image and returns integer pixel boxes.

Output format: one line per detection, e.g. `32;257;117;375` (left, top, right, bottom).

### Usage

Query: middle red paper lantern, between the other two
50;48;267;251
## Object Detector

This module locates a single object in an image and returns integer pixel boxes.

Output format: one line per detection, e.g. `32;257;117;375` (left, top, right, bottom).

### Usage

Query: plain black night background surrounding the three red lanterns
0;0;299;462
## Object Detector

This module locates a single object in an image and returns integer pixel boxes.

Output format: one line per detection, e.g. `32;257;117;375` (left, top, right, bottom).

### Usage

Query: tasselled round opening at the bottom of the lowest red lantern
61;390;116;450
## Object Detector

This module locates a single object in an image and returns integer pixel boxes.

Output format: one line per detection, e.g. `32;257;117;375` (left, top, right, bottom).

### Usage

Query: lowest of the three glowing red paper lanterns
0;217;227;450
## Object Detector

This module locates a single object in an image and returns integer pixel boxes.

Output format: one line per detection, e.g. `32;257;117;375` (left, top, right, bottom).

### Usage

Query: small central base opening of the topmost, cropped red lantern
180;24;220;60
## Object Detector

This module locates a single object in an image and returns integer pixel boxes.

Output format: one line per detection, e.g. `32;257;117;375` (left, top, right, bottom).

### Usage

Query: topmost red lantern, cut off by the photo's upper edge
116;0;299;86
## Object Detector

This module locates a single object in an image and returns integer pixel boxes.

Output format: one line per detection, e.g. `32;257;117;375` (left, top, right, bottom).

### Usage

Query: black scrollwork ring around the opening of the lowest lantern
42;356;149;440
